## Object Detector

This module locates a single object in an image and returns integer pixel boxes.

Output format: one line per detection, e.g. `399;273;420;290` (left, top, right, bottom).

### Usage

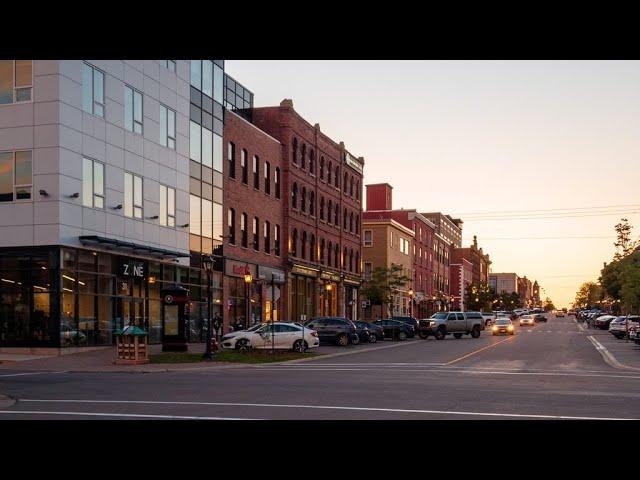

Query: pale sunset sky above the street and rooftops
225;60;640;307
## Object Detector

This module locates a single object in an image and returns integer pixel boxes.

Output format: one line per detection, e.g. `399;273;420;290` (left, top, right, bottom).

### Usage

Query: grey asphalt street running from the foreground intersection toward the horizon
0;317;640;420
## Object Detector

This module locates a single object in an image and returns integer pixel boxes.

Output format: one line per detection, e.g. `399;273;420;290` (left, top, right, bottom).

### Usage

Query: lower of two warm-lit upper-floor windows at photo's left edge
0;150;33;202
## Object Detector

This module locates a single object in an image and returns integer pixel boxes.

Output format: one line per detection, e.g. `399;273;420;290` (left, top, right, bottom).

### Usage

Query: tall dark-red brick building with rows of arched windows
251;100;364;321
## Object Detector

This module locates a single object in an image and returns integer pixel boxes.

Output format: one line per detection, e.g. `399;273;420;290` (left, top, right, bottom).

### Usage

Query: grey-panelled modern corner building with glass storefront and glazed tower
0;60;238;349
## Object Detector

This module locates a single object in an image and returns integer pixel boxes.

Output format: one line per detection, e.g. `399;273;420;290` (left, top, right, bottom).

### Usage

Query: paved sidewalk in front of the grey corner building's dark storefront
0;343;246;373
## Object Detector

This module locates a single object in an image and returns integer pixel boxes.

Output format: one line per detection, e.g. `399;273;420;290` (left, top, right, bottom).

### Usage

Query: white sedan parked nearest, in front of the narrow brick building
221;322;320;352
